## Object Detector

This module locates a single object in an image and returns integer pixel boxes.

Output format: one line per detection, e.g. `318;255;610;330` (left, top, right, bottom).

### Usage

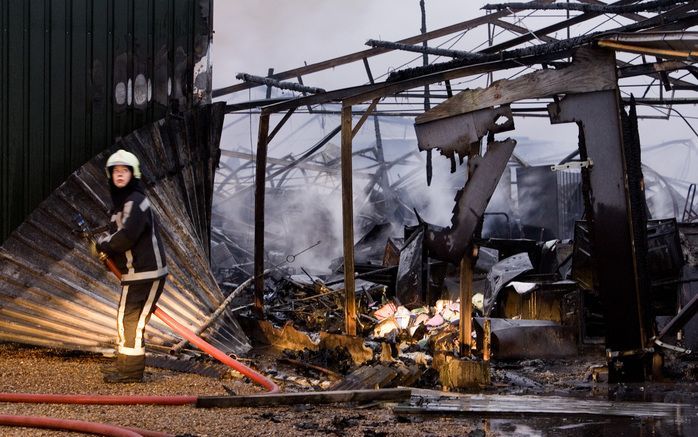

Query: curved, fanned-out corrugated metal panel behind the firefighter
0;104;249;353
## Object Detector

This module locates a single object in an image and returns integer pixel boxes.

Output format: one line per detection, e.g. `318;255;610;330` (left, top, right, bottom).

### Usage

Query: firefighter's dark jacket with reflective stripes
97;190;167;284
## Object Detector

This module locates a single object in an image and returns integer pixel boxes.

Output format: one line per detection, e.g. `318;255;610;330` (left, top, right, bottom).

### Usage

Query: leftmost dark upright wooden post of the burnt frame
254;112;270;319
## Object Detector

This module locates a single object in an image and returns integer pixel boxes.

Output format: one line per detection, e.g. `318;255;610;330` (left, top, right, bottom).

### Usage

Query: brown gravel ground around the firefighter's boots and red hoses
0;343;484;437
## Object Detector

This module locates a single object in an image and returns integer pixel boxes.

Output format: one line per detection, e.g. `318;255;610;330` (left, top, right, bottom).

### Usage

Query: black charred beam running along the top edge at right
481;0;689;14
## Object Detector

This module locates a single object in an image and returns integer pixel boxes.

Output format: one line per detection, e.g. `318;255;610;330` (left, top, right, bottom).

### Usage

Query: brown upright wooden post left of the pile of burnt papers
341;106;356;335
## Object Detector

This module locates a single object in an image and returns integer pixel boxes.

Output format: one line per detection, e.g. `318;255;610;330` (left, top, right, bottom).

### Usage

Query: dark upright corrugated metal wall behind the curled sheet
0;0;213;242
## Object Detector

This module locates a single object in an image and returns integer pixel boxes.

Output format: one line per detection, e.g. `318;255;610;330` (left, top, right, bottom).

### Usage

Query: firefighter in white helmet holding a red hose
97;150;167;382
